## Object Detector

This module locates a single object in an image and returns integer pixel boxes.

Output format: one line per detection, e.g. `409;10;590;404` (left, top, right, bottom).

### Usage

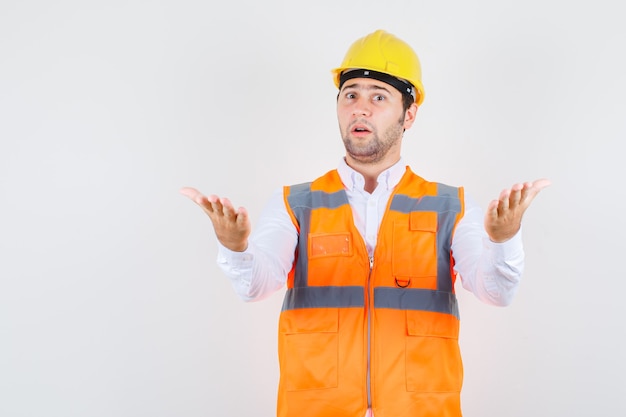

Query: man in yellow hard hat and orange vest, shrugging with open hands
181;30;549;417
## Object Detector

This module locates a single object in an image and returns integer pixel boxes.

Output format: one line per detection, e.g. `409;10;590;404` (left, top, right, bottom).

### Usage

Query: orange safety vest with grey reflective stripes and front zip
278;167;464;417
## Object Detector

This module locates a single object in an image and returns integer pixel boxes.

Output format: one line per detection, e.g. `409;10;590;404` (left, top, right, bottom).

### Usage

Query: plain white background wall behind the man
0;0;626;417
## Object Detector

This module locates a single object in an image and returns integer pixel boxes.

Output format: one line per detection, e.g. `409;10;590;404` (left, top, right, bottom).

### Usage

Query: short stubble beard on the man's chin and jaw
343;117;404;164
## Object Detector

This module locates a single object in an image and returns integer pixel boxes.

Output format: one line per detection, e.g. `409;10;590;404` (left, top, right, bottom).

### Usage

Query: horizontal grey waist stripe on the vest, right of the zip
374;287;459;318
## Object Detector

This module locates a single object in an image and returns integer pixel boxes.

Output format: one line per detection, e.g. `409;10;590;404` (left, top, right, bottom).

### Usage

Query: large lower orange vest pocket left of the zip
281;308;339;391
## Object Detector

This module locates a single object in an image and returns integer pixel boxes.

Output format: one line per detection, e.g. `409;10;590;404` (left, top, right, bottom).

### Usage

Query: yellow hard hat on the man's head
332;30;424;106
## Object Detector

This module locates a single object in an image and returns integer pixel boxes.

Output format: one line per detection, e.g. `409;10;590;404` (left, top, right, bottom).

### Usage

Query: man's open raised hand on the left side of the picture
180;187;252;252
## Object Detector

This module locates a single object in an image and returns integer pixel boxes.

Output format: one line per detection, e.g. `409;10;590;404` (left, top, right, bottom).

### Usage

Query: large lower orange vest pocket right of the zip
406;311;463;392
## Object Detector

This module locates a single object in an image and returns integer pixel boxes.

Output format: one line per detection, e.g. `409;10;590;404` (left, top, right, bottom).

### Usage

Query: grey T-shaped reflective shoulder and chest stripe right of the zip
389;184;461;293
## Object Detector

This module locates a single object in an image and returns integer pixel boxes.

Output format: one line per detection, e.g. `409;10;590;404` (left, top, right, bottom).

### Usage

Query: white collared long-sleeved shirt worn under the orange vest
217;158;524;306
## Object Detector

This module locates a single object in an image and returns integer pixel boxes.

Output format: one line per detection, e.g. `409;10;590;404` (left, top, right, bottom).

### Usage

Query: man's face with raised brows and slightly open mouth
337;78;417;163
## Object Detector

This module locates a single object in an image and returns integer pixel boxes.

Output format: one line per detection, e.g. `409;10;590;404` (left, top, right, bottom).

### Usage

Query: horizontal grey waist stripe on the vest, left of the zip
283;286;365;311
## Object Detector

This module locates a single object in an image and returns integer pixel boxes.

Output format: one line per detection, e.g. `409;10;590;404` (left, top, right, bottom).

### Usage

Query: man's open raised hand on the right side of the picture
485;179;550;242
